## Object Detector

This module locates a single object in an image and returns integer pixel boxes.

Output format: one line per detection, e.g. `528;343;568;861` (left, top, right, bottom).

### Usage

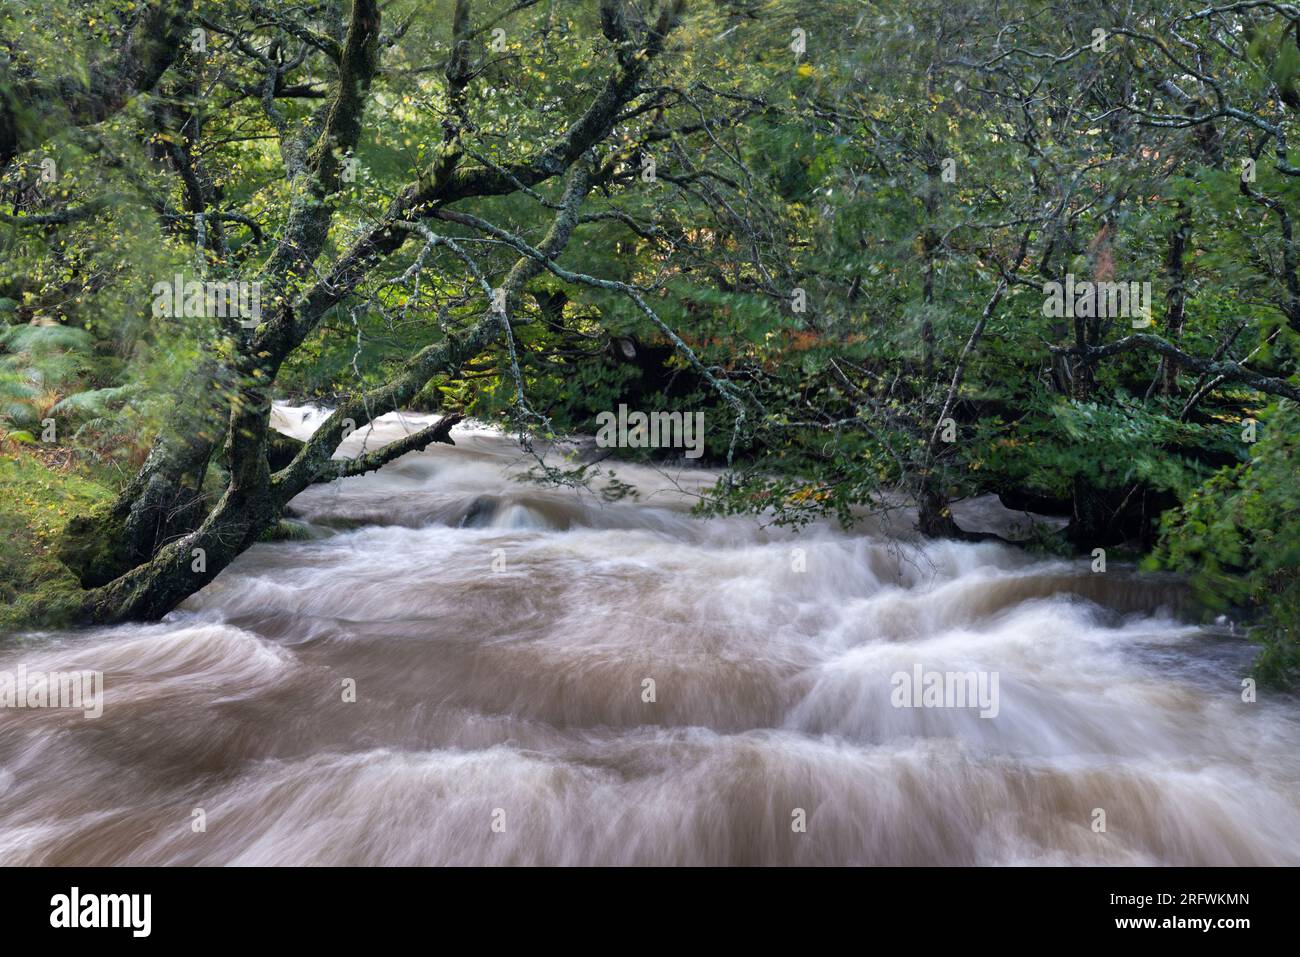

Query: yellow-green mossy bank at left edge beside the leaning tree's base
0;451;113;635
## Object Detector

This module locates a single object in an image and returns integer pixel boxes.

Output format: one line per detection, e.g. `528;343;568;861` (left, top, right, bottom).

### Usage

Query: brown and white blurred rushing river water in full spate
0;408;1300;865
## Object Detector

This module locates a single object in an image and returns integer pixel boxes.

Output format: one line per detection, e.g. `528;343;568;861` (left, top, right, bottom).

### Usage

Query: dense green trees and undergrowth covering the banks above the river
0;0;1300;681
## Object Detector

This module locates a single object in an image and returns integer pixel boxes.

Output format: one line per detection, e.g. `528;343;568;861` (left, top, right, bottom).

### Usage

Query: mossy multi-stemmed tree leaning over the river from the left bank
2;0;811;620
